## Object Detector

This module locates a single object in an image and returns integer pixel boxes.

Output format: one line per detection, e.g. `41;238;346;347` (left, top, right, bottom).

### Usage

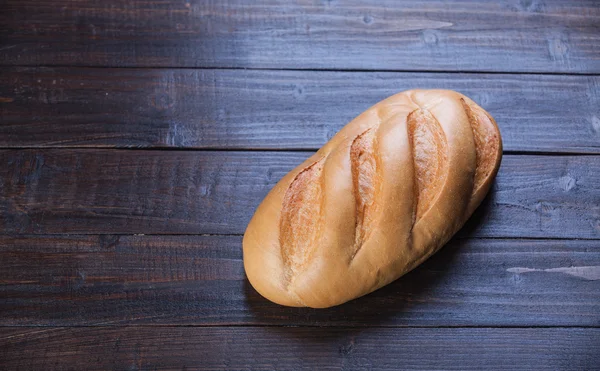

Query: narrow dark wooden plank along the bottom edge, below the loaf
0;327;600;370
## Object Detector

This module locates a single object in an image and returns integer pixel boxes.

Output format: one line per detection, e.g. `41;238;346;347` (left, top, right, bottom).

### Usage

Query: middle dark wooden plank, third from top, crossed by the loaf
0;149;600;238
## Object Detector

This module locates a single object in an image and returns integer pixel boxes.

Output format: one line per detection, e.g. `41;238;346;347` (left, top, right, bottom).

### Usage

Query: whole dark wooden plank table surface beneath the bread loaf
0;0;600;370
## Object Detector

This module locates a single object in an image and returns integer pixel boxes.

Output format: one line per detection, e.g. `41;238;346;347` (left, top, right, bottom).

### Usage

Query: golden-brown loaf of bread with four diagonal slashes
243;90;502;308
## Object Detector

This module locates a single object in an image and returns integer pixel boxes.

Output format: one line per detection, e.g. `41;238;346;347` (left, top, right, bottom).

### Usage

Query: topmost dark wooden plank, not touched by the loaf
0;0;600;73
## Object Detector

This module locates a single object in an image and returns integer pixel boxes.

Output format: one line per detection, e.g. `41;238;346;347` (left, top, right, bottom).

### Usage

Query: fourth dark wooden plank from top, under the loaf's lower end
0;235;600;327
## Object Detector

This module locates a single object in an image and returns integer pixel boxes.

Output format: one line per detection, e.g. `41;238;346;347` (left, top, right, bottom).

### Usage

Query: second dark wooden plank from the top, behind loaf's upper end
0;68;600;153
